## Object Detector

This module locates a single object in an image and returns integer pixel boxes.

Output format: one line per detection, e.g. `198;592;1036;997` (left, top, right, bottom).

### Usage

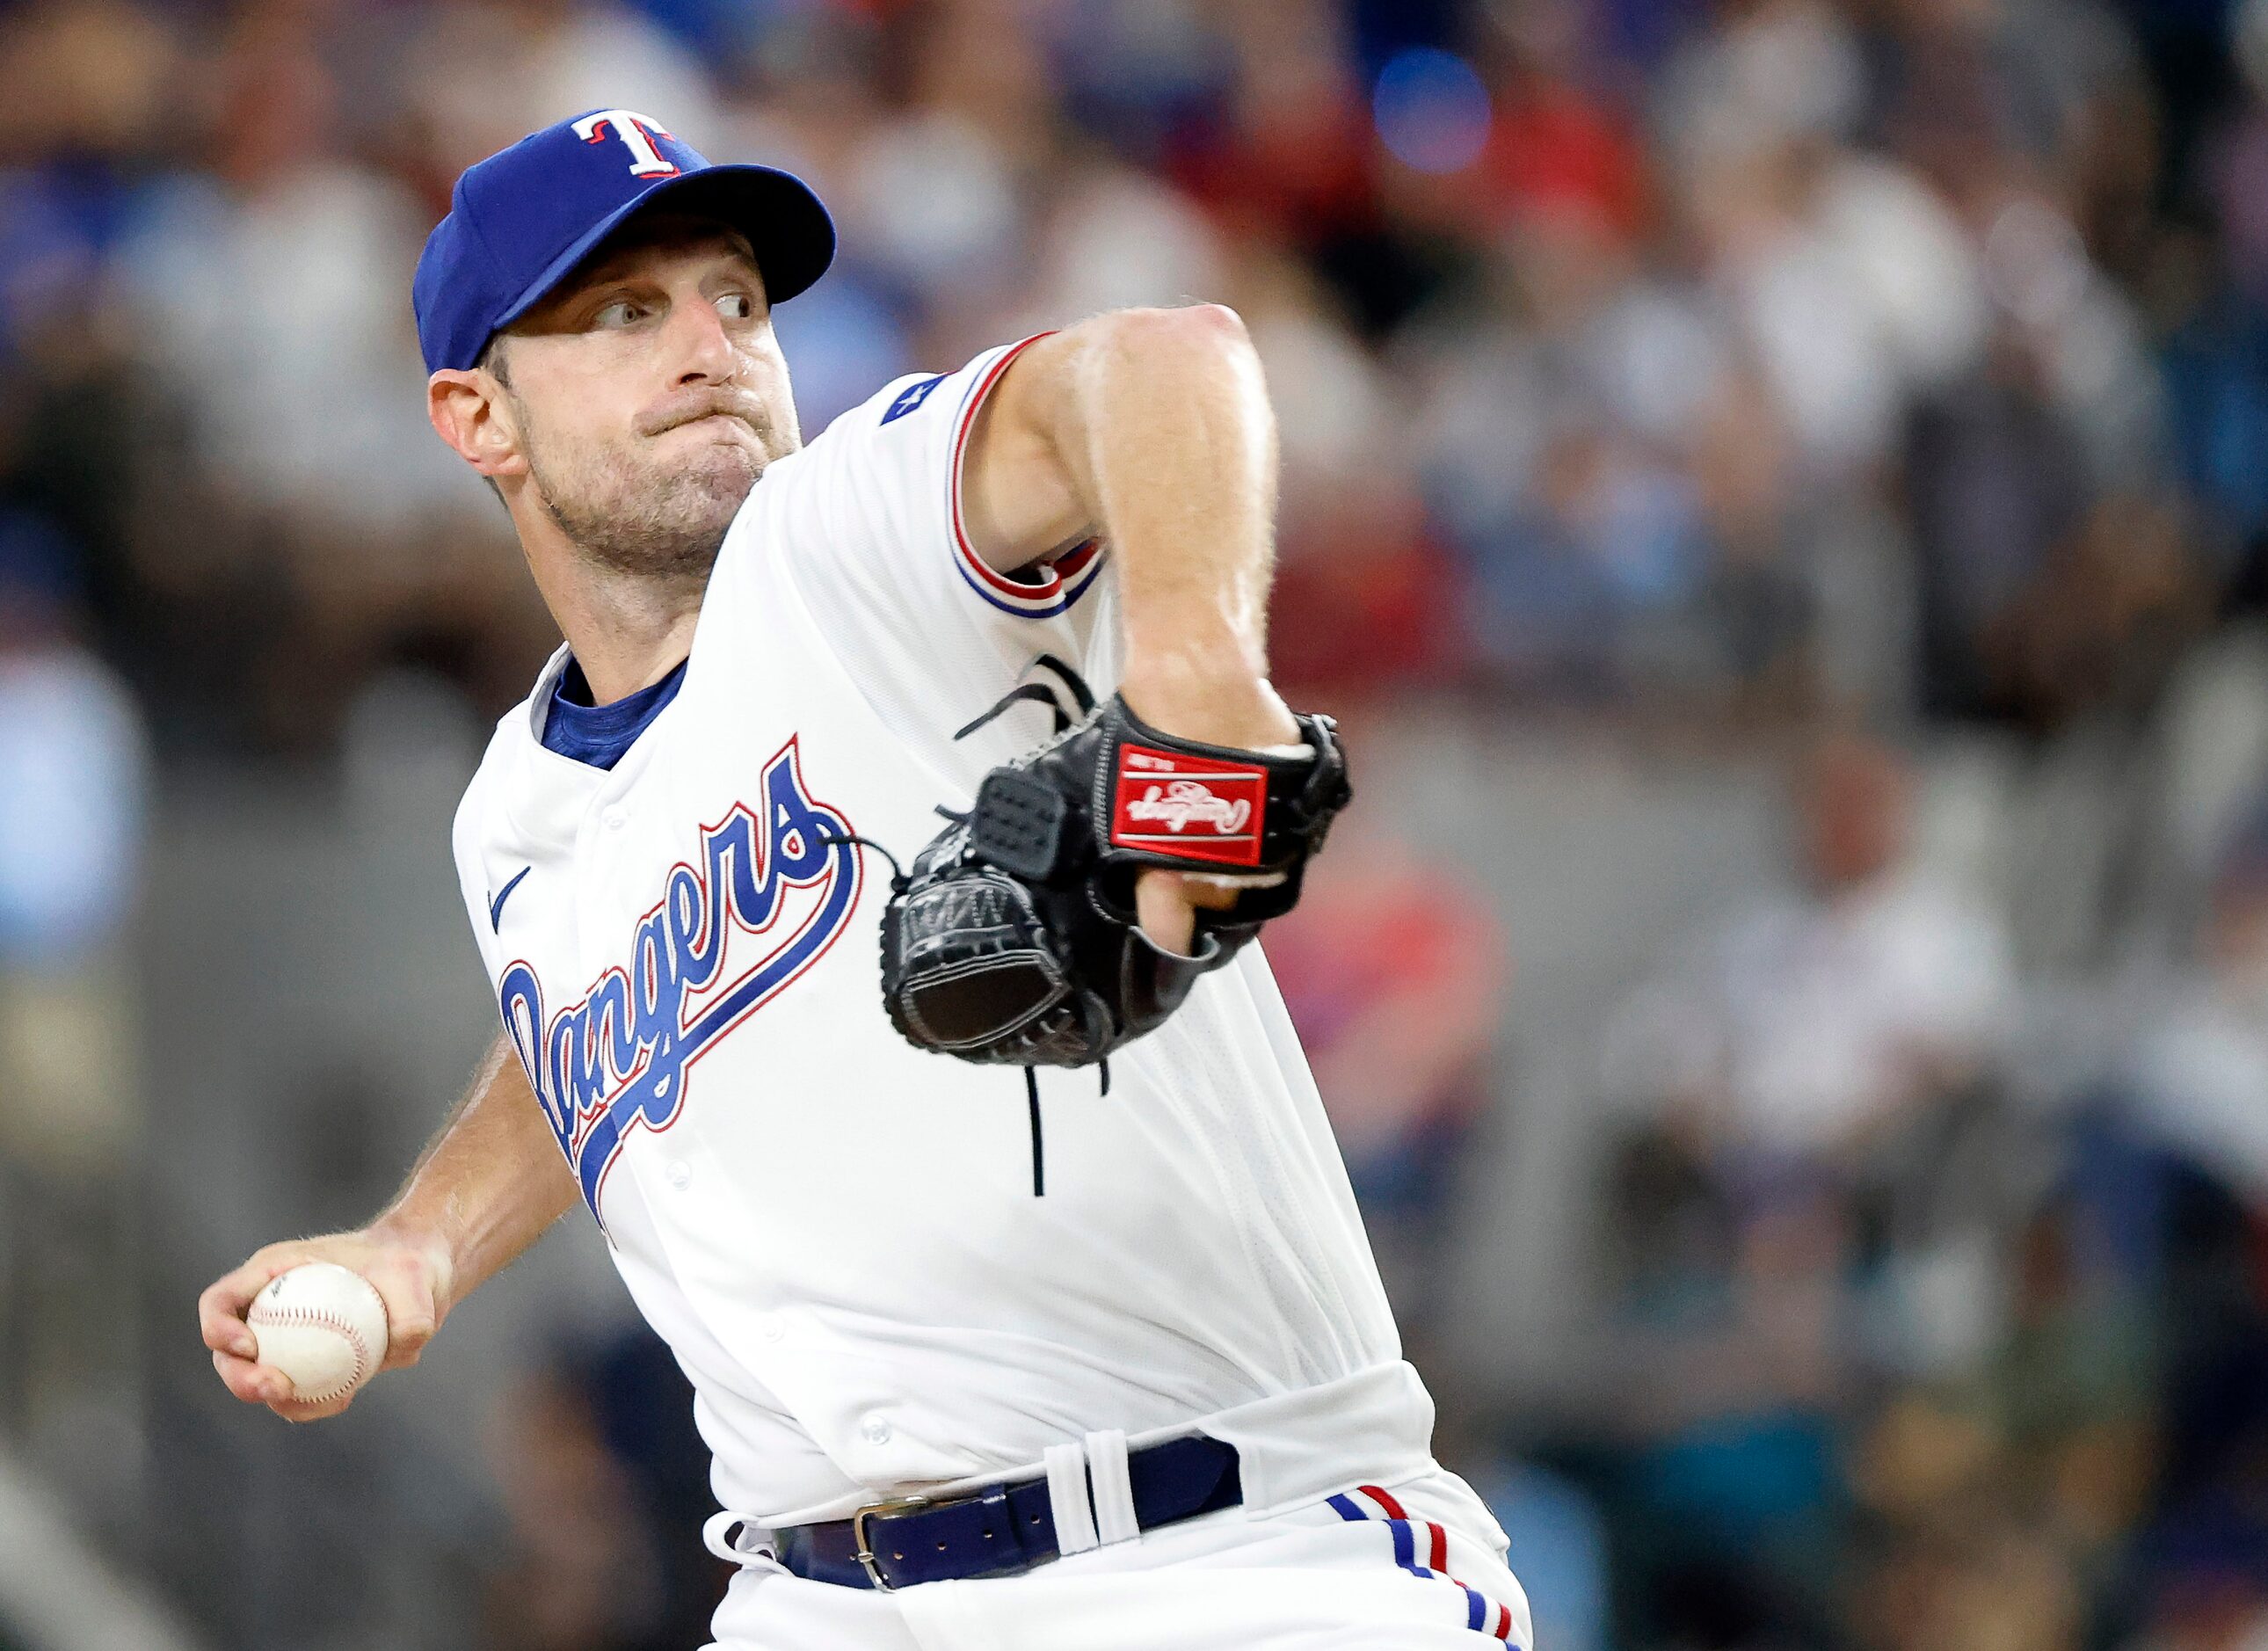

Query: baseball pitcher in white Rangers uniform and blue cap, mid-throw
200;109;1529;1651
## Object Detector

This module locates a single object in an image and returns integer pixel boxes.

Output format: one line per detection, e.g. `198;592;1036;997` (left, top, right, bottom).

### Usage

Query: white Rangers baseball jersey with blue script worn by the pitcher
456;331;1493;1529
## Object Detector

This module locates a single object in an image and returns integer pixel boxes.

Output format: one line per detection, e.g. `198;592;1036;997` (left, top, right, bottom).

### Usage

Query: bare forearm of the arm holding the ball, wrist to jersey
372;1036;576;1299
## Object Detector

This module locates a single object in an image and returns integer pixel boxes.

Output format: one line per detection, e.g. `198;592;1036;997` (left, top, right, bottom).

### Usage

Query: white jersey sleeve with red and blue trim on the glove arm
744;333;1118;775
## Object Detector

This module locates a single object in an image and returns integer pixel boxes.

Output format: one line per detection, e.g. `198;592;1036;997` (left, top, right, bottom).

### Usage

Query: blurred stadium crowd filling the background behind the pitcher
0;0;2268;1651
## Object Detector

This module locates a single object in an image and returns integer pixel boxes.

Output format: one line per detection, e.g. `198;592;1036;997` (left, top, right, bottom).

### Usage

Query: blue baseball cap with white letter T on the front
411;109;834;372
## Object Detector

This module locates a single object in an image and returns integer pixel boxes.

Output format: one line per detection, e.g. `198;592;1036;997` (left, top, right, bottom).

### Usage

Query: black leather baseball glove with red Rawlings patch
883;660;1352;1066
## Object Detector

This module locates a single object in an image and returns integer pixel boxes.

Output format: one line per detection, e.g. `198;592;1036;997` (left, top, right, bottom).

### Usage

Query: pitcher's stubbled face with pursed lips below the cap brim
488;215;803;578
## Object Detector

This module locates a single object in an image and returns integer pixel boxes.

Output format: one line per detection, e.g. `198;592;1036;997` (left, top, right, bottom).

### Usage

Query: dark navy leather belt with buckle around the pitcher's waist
771;1433;1243;1595
